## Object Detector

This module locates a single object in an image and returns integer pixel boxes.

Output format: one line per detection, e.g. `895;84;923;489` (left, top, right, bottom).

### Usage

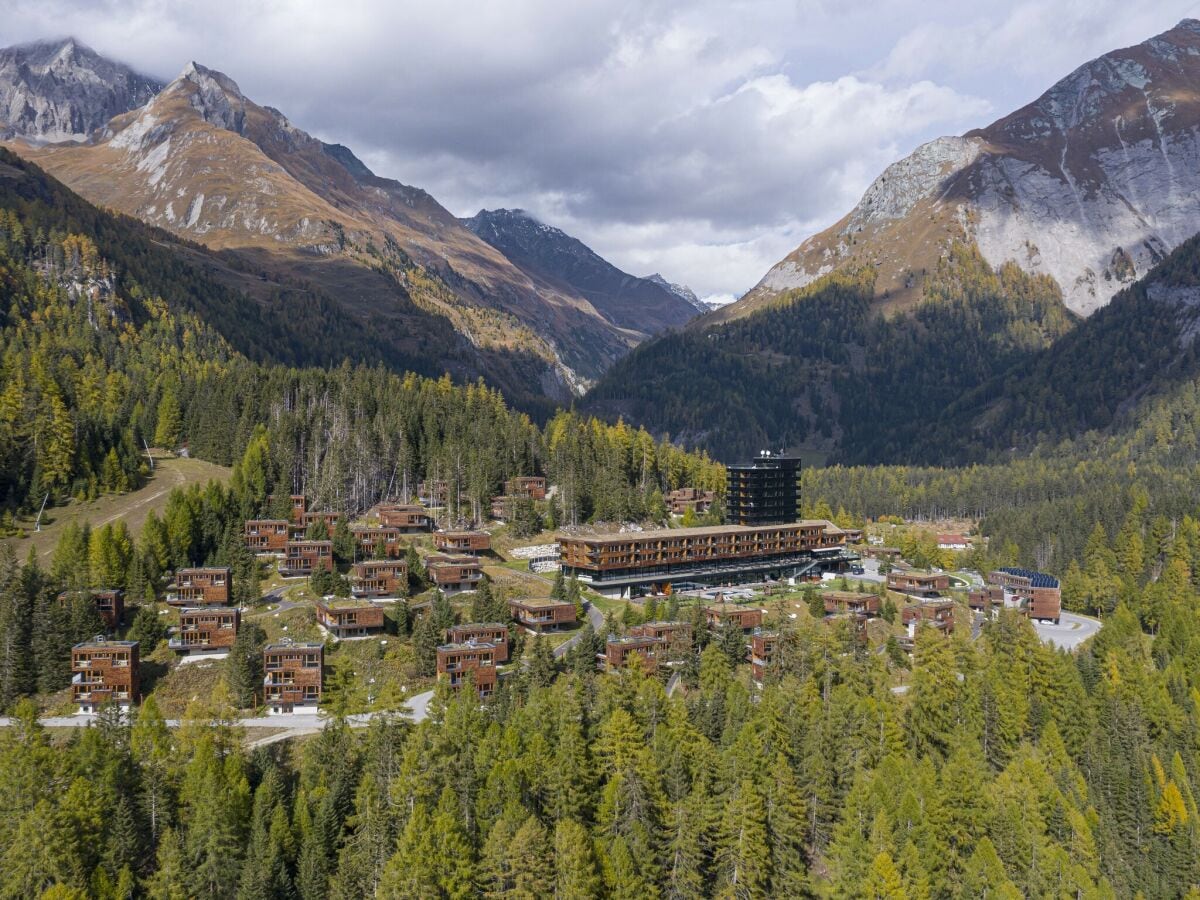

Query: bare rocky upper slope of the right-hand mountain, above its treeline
744;19;1200;317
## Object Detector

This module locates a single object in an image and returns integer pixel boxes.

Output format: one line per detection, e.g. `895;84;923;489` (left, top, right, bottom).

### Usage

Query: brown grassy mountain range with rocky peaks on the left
0;38;695;403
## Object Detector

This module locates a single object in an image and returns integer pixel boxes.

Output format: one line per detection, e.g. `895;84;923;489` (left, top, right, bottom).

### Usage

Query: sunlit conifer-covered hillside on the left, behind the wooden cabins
0;147;722;524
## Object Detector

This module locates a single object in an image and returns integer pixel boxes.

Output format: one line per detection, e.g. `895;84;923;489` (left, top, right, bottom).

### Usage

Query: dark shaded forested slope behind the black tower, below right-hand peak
586;244;1074;462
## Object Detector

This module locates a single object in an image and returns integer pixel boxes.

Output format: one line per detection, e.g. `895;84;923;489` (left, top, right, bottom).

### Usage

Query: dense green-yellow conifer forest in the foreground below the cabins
0;587;1200;899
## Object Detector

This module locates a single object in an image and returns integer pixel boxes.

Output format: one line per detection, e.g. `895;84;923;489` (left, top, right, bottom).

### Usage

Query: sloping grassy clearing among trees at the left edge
0;457;230;560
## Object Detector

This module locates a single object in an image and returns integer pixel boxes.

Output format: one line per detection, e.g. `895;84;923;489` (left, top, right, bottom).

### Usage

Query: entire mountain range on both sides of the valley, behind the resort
7;19;1200;463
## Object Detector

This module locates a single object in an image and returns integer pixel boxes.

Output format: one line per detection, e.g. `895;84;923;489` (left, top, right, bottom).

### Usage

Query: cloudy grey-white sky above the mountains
0;0;1200;303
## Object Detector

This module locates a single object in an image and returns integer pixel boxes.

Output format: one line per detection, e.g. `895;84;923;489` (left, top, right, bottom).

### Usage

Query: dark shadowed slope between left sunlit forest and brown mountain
0;148;571;418
